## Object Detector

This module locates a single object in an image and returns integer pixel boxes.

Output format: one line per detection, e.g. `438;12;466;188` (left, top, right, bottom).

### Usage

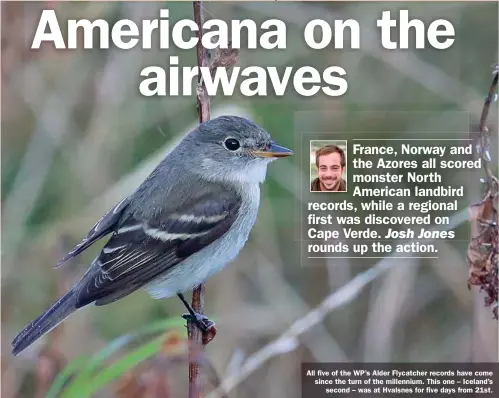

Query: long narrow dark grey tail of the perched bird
12;289;78;355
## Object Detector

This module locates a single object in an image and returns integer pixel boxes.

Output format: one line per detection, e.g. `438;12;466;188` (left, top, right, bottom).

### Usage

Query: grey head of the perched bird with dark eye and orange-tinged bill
179;116;293;182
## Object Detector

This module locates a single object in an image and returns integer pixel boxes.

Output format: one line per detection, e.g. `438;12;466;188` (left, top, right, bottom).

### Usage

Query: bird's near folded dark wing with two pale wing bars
73;191;241;307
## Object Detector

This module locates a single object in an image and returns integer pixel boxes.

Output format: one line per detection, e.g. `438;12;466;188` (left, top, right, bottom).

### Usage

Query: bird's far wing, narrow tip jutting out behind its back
56;197;130;267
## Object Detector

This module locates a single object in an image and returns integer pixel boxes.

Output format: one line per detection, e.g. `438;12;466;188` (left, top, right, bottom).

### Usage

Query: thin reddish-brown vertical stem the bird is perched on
187;1;210;398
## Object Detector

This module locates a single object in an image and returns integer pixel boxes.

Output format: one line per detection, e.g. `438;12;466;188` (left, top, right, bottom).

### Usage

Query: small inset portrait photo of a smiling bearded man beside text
310;140;347;192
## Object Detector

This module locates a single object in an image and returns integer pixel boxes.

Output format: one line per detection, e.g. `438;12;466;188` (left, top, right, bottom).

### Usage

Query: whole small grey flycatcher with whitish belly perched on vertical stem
12;116;292;355
